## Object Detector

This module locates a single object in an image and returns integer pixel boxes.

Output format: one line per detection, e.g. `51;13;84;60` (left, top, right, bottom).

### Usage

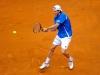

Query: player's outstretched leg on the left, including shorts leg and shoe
40;37;60;69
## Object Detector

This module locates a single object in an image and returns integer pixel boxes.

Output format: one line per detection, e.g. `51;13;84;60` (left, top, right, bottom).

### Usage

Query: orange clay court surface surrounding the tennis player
0;0;100;75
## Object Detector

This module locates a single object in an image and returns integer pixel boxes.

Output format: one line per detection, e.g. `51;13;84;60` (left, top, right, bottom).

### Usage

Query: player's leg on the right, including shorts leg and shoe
61;37;74;69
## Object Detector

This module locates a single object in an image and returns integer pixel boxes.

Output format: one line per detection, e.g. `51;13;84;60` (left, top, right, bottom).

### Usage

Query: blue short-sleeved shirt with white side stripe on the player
54;12;72;38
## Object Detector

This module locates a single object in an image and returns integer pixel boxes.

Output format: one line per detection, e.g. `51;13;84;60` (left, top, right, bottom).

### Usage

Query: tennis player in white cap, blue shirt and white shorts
40;5;74;69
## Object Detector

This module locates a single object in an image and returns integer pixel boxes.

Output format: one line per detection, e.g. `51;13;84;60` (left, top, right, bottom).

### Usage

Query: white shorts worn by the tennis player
53;35;71;50
